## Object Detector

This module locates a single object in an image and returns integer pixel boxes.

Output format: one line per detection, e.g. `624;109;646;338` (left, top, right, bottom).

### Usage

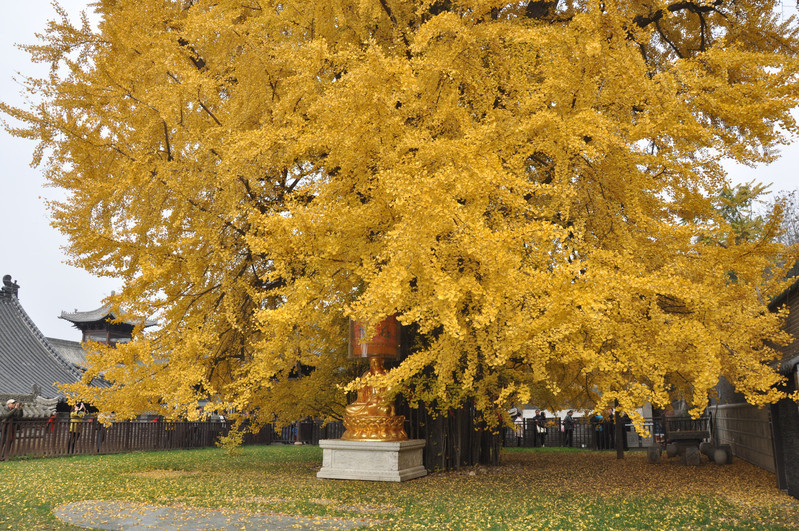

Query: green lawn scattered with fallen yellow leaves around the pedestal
0;446;799;530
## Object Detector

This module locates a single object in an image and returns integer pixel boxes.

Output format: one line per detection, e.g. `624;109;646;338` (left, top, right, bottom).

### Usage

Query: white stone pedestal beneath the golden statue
316;439;427;482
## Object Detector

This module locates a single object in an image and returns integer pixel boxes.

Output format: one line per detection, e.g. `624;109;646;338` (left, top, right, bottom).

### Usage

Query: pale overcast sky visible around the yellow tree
0;0;799;341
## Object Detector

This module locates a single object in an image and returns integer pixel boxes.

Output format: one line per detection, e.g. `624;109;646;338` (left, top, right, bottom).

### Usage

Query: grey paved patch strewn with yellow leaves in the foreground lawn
53;501;378;531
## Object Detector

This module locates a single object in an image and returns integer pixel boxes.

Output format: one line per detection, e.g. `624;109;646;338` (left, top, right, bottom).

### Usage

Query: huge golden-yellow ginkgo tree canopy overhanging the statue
2;0;799;428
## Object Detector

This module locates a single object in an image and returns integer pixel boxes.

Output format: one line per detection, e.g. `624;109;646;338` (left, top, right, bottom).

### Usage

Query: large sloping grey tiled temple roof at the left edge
0;284;87;398
